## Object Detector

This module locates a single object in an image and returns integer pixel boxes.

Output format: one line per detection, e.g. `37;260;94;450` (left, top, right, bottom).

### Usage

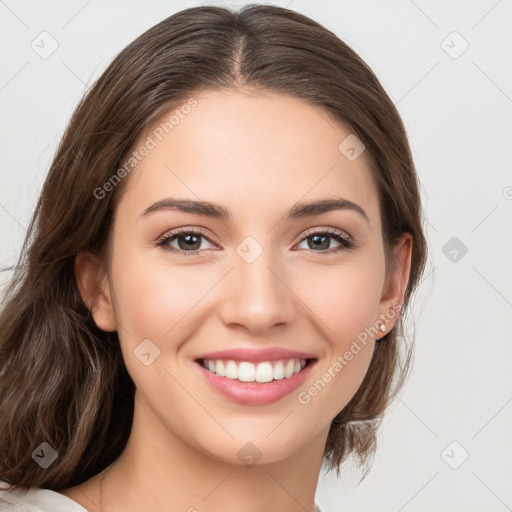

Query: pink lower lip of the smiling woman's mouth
195;361;314;405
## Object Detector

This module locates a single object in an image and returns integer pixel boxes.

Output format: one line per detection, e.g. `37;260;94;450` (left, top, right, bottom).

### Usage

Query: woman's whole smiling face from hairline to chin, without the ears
88;91;410;463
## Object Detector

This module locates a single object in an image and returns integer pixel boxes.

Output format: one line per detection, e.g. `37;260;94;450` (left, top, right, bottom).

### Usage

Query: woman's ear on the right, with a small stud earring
377;233;413;339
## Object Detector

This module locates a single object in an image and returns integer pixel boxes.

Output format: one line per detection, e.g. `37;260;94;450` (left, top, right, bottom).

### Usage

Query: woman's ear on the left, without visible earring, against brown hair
75;252;117;331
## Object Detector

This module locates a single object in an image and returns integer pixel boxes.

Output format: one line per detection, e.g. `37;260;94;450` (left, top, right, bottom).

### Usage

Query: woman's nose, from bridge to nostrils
219;244;297;335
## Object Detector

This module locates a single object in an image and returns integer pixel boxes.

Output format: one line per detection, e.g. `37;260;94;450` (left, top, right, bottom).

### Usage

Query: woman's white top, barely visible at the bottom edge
0;482;322;512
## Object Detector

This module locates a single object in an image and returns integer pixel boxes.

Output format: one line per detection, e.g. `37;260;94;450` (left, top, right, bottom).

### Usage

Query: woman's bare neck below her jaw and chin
102;390;328;512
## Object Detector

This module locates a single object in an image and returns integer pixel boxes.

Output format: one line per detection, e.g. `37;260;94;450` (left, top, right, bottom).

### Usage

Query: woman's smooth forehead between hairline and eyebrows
120;90;378;228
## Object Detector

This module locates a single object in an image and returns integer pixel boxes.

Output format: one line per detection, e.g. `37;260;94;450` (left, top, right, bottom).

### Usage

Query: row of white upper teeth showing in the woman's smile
202;359;306;382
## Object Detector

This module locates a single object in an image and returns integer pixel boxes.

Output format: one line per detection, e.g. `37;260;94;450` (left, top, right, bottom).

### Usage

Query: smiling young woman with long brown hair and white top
0;5;426;512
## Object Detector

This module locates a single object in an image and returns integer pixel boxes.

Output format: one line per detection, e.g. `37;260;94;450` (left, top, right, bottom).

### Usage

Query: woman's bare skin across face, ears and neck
61;89;412;512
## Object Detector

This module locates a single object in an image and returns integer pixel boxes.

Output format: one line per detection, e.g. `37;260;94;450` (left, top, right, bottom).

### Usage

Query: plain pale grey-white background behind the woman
0;0;512;512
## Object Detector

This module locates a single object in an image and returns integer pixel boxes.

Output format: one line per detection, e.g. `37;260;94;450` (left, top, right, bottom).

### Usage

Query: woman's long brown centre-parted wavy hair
0;5;427;490
